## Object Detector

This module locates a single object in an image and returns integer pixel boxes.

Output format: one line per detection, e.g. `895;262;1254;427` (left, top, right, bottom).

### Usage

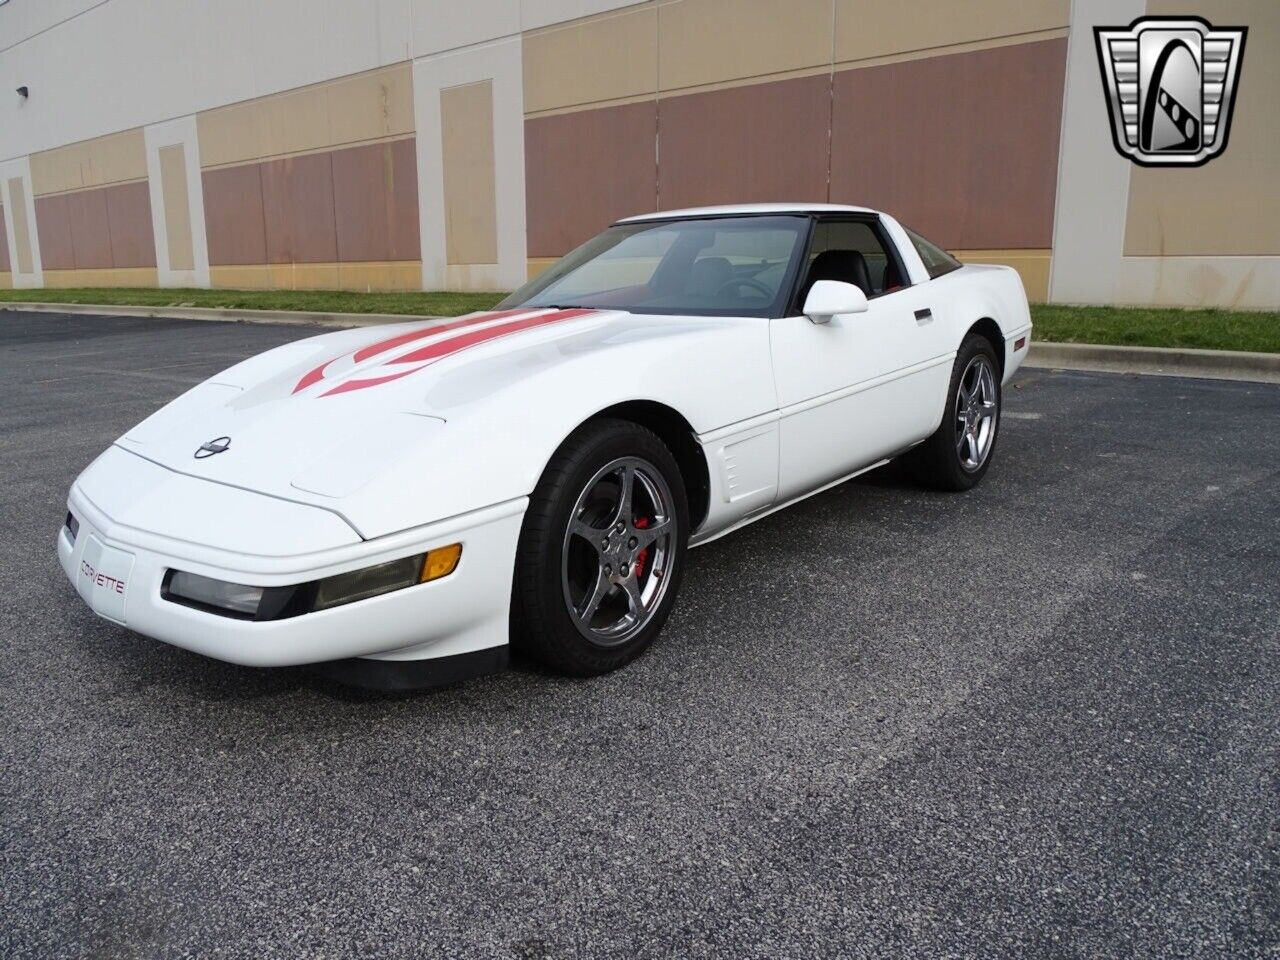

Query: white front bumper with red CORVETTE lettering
58;455;526;667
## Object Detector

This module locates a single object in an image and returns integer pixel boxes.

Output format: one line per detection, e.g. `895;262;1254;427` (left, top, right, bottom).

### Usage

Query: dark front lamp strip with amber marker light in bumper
160;543;462;621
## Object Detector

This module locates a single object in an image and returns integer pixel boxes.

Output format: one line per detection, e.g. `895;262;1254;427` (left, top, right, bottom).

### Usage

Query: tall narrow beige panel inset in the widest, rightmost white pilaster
440;81;498;264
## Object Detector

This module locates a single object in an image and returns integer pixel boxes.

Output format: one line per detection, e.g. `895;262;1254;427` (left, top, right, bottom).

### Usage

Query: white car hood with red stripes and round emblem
107;308;767;538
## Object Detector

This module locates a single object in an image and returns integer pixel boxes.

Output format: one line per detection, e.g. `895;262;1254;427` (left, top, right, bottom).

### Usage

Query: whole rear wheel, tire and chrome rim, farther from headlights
908;335;1001;490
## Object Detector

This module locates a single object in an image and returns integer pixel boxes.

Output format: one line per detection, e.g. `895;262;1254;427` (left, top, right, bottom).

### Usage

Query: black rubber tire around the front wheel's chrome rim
511;419;689;676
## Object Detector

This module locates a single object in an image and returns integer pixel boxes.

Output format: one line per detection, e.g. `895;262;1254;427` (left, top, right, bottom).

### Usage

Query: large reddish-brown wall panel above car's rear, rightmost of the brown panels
824;38;1066;250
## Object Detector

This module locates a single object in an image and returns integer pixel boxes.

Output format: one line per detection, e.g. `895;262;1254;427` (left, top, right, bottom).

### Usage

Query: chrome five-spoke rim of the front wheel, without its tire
561;457;677;648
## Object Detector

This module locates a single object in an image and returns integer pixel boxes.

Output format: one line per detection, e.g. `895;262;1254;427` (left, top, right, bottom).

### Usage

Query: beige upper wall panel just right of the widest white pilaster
522;4;658;114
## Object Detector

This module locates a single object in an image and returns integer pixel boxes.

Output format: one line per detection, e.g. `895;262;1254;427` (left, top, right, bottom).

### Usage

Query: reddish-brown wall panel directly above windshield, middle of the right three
658;76;831;215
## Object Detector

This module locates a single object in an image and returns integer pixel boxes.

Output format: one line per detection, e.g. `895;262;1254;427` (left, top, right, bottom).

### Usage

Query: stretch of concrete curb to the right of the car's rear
1024;340;1280;383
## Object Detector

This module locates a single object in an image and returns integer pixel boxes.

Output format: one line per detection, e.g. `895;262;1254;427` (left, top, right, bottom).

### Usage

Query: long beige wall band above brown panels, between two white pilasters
196;63;413;168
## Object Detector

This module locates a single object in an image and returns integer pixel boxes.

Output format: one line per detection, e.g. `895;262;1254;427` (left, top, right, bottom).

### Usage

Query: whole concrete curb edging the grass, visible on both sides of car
0;302;1280;383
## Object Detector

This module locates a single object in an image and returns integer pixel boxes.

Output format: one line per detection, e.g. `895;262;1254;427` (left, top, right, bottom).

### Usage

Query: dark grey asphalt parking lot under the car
0;314;1280;960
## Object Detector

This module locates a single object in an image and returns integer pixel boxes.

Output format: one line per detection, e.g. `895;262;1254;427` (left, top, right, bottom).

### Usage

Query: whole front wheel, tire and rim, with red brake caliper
511;420;689;676
